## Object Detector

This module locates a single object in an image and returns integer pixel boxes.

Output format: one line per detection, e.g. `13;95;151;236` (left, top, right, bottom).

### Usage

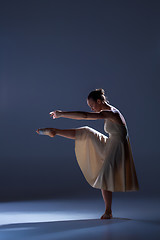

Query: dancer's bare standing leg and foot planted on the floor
101;189;112;219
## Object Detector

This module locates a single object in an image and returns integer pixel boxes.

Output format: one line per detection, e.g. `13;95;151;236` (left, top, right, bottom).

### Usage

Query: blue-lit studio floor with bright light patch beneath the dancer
0;197;160;240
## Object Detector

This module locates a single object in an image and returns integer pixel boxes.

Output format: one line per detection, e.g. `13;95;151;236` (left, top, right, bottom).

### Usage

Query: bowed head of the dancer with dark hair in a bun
87;88;109;112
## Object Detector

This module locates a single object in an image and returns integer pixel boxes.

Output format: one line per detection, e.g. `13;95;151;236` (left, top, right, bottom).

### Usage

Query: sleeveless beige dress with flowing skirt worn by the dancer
75;115;139;192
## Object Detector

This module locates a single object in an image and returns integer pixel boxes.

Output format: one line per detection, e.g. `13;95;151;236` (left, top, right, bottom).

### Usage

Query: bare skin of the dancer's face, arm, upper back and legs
36;98;126;219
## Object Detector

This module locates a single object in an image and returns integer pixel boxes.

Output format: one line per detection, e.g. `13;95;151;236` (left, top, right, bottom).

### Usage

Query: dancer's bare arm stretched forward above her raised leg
50;110;115;120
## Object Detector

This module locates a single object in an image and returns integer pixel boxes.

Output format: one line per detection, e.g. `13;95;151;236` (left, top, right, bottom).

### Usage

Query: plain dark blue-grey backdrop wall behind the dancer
0;0;160;201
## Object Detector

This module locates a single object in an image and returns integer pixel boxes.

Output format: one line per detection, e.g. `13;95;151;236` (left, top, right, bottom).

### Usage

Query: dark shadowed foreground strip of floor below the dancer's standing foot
0;218;160;240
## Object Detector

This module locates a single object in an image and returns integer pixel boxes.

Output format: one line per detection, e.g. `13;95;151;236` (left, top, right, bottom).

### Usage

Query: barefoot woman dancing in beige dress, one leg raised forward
36;89;139;219
